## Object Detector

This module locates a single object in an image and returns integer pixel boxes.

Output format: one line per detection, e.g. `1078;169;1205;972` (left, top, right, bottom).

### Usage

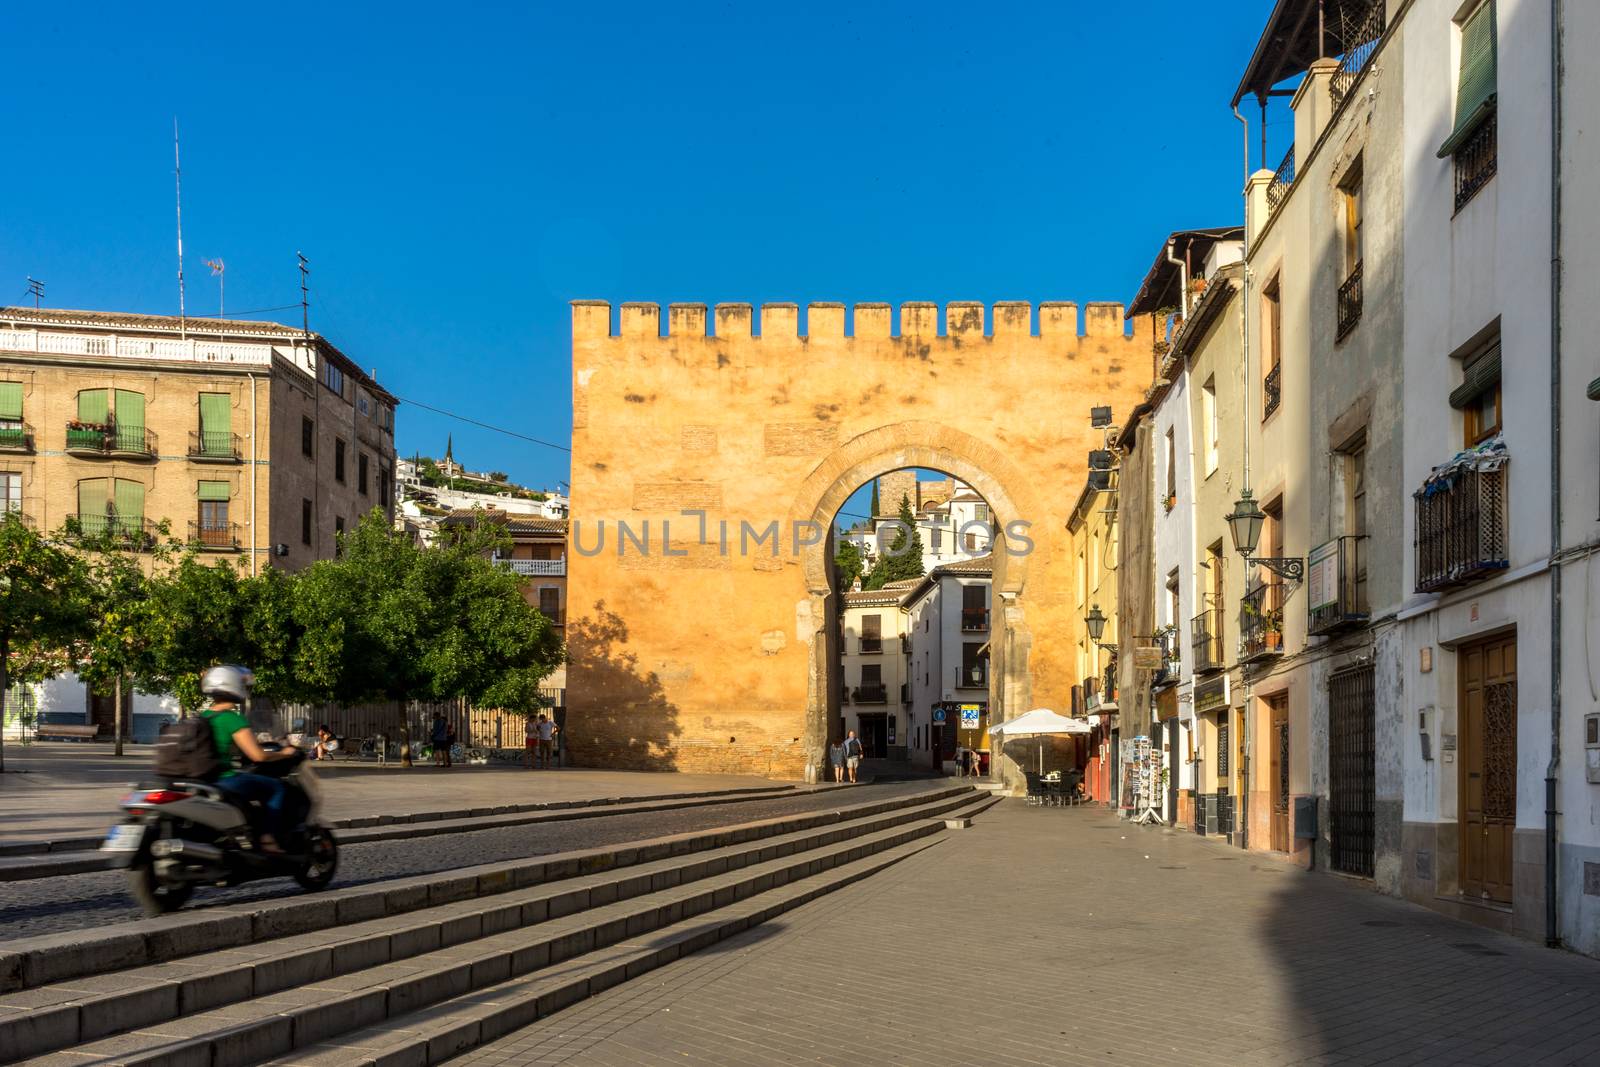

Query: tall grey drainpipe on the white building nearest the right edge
1544;0;1562;949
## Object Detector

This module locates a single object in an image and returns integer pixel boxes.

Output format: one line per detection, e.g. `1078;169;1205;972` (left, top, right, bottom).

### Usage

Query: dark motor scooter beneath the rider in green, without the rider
101;742;339;915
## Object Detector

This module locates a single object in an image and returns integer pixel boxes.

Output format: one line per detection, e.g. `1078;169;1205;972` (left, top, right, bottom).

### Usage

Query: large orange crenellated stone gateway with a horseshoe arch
566;301;1155;779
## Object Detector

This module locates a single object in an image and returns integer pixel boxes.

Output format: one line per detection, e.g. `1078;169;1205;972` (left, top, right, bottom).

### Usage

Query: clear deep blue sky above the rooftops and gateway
0;0;1272;486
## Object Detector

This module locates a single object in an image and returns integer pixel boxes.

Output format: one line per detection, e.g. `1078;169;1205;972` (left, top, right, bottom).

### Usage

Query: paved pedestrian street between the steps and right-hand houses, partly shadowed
456;800;1600;1067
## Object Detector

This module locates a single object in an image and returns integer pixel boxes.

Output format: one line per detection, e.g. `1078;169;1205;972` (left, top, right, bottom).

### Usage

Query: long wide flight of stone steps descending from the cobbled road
0;782;997;1067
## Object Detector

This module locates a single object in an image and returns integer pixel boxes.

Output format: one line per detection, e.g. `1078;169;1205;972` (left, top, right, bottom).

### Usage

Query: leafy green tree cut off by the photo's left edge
0;512;88;771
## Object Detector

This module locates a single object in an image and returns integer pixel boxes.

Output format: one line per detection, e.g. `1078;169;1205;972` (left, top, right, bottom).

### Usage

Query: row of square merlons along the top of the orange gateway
571;301;1157;341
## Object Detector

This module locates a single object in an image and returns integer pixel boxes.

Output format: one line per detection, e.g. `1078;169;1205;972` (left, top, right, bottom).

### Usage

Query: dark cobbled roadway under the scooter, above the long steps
0;771;939;942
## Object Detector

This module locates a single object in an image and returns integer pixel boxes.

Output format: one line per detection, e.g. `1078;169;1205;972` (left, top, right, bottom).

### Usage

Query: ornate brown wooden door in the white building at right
1456;637;1517;904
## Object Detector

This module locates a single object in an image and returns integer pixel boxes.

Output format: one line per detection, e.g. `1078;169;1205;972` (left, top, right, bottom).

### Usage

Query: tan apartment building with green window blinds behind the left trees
0;307;397;733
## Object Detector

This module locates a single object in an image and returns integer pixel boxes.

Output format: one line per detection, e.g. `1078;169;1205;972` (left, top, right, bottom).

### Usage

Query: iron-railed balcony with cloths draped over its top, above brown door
1414;459;1510;593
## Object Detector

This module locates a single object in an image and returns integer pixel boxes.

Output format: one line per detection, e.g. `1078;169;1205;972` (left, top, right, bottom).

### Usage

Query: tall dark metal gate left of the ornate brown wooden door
1328;664;1378;878
